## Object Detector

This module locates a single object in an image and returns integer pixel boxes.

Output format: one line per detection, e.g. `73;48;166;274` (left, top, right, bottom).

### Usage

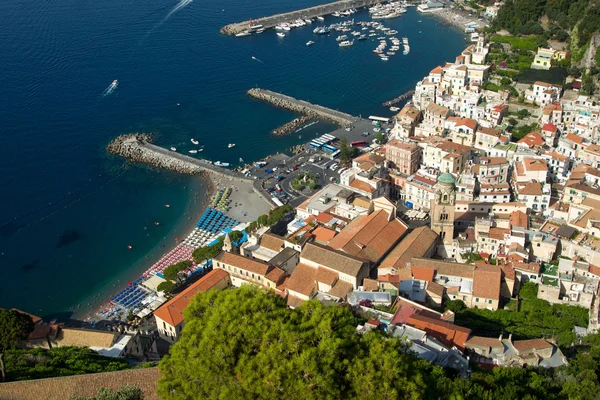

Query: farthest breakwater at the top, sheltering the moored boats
221;0;385;35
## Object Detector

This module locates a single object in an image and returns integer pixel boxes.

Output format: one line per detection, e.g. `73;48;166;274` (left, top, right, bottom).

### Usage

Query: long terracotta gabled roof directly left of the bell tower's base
380;226;438;269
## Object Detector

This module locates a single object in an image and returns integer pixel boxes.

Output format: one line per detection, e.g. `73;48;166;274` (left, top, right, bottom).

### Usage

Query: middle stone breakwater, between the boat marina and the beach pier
248;88;358;126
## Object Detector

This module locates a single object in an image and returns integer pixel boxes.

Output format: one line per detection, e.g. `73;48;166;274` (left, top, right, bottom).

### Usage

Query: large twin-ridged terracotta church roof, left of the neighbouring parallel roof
329;209;408;262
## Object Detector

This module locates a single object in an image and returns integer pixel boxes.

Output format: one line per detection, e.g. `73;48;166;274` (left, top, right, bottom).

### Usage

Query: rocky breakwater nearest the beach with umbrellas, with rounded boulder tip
106;133;205;175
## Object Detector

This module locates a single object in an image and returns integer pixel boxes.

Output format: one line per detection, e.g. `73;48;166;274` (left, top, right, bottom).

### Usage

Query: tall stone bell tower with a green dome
430;172;456;245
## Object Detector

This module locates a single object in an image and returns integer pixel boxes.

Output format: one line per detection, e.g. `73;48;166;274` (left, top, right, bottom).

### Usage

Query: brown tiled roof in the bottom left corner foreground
0;367;160;400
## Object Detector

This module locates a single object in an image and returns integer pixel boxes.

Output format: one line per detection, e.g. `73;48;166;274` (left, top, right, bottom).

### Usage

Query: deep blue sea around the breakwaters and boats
0;0;465;317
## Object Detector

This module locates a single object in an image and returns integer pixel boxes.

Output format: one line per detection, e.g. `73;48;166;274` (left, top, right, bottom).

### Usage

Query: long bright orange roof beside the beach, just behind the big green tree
153;269;229;326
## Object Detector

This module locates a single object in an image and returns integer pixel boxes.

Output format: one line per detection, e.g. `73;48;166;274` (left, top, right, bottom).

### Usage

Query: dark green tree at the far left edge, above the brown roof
0;309;34;381
